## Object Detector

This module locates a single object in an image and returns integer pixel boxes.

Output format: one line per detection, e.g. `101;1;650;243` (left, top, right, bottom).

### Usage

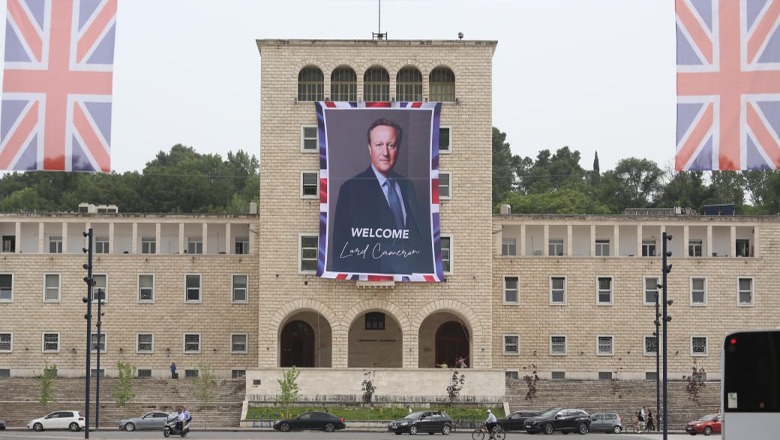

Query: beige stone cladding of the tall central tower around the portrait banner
257;40;496;368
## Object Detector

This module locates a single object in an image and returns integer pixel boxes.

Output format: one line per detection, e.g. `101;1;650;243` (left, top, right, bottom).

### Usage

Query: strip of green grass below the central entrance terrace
246;405;504;420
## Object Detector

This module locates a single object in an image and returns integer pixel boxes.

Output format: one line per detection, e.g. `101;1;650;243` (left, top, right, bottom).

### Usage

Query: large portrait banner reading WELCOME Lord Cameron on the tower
316;101;444;282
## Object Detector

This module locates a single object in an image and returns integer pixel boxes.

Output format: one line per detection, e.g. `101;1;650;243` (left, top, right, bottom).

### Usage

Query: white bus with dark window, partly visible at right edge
721;330;780;440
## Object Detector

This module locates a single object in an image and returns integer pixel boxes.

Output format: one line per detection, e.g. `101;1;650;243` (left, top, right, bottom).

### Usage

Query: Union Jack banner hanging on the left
0;0;118;172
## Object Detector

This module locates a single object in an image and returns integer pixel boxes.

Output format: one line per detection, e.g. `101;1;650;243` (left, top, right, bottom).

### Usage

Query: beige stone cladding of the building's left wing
0;214;258;377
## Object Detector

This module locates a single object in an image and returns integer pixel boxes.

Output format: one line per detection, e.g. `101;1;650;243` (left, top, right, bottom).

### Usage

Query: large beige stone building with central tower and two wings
0;40;780;397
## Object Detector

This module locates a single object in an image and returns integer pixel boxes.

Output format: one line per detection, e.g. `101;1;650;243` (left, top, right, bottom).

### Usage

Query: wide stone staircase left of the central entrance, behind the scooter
0;378;246;429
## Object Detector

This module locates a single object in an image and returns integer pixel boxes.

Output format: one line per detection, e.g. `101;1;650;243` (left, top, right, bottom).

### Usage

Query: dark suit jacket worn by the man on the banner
328;167;434;275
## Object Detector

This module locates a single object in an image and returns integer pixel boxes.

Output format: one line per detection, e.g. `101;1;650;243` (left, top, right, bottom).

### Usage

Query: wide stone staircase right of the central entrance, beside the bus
506;379;720;430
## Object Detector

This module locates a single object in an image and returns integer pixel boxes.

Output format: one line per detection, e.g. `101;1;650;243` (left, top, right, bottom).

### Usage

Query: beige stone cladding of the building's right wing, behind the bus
492;215;780;379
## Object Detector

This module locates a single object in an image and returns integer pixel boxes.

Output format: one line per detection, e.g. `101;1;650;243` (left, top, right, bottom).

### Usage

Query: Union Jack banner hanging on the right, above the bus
675;0;780;170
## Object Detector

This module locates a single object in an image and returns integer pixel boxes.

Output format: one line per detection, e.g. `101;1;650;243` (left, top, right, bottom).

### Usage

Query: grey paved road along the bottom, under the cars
0;429;720;440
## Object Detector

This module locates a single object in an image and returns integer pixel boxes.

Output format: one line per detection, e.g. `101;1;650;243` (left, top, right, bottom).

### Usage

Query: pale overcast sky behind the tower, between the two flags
0;0;676;172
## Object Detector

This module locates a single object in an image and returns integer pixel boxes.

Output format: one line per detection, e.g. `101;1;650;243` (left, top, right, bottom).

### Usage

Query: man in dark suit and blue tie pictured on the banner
330;118;434;275
